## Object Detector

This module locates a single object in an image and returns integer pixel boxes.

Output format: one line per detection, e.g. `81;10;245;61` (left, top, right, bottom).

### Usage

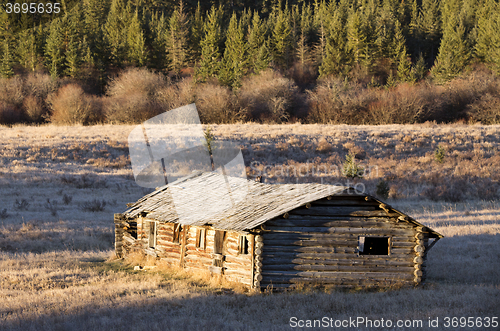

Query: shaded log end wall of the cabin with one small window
254;197;425;287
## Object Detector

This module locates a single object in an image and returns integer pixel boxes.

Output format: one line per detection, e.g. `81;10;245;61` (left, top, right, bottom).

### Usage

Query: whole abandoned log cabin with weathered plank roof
114;172;443;289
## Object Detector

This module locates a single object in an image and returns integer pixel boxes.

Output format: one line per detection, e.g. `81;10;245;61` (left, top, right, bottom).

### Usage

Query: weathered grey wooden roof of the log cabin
123;172;442;237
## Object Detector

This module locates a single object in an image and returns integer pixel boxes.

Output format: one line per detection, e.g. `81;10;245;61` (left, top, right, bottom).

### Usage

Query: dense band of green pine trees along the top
0;0;500;88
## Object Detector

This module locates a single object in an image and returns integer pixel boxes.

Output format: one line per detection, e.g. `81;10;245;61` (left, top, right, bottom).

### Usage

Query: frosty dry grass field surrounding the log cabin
0;123;500;331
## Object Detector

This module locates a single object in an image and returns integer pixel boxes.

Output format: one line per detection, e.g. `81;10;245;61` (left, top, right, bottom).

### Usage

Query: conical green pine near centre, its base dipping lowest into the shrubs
219;13;247;88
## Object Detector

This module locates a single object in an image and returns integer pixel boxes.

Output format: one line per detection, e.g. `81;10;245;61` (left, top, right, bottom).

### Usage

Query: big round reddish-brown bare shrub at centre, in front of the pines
237;70;301;123
